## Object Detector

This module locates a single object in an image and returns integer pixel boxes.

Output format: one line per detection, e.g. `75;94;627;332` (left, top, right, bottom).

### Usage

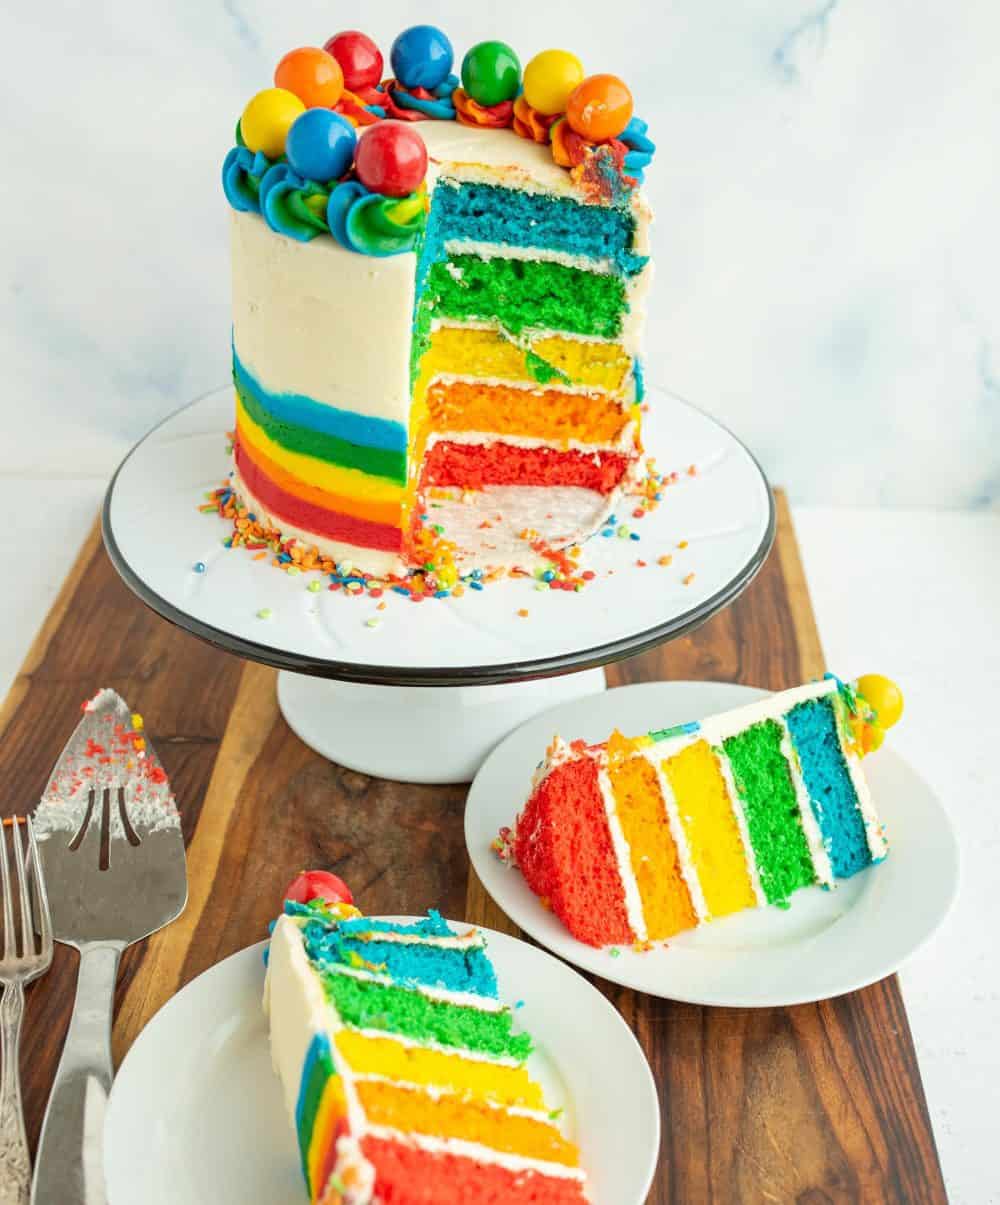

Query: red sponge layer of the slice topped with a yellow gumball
514;758;635;946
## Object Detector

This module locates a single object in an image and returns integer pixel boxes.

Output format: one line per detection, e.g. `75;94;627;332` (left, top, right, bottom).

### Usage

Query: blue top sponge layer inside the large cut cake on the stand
424;184;647;276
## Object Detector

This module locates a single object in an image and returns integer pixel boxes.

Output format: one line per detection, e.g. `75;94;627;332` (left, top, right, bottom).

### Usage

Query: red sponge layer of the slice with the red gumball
361;1135;587;1205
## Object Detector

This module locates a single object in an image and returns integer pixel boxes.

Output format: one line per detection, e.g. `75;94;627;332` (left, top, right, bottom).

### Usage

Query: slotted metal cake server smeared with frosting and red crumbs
31;690;188;1205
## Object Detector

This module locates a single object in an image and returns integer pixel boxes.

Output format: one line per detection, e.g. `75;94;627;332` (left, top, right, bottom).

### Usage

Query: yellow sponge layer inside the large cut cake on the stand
420;327;631;393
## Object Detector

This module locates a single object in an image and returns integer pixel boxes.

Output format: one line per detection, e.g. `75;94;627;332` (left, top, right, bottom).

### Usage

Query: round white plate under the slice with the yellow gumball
465;682;959;1007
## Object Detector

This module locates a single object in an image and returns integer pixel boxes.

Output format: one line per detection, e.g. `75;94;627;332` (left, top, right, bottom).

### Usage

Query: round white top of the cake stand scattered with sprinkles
104;389;773;686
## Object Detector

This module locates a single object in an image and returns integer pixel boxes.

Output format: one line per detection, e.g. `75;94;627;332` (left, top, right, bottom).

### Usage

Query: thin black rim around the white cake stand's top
101;389;777;687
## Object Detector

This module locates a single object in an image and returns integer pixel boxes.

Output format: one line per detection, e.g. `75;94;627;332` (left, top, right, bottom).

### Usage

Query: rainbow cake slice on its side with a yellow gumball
506;675;902;946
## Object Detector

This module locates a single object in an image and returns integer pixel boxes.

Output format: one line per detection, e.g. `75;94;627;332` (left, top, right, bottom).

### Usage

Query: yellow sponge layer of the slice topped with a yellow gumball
663;741;757;916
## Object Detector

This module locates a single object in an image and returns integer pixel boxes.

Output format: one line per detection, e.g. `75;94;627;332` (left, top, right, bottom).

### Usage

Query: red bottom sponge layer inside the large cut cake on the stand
423;440;630;494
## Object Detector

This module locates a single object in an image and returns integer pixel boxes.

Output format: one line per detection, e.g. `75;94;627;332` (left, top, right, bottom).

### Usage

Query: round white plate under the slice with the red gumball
105;917;660;1205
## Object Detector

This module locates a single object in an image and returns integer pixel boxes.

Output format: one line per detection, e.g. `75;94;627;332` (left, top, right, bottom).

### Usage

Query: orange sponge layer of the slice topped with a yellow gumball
607;743;698;941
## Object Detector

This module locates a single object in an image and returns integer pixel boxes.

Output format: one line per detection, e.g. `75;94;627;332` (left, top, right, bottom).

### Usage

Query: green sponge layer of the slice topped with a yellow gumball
723;719;816;904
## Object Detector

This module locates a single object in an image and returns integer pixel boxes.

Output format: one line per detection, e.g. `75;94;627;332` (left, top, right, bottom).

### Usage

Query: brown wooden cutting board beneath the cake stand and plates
0;495;946;1205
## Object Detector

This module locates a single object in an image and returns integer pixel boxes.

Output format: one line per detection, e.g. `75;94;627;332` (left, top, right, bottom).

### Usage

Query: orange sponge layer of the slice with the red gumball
357;1080;577;1166
